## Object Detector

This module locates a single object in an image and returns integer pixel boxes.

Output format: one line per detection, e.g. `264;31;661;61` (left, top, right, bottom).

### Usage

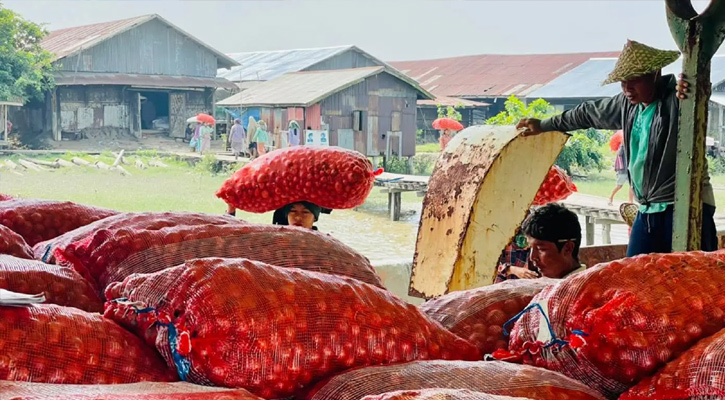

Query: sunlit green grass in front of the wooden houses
0;153;725;216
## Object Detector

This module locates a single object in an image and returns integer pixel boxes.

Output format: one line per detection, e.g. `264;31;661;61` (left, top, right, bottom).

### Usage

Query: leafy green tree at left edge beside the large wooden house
0;3;54;102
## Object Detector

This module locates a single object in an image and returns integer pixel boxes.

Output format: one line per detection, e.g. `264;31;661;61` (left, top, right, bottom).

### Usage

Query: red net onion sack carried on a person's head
217;146;382;213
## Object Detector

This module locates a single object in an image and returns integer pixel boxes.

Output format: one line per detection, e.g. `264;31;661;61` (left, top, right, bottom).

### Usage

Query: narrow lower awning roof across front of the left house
53;71;237;89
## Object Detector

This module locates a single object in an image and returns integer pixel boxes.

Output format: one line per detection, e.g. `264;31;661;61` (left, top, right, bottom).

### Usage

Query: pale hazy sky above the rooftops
0;0;725;61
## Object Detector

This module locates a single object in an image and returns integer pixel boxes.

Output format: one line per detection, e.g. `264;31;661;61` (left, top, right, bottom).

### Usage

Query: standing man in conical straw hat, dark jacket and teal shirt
517;40;718;257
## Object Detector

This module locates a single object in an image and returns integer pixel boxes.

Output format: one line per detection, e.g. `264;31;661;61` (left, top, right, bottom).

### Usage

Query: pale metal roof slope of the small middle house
217;67;385;107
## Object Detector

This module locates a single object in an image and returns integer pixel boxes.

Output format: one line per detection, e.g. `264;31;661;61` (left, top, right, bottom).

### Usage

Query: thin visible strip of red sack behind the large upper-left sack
33;212;243;263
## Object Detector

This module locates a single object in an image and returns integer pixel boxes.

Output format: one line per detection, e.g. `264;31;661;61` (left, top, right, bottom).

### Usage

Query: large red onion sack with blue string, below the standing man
509;252;725;398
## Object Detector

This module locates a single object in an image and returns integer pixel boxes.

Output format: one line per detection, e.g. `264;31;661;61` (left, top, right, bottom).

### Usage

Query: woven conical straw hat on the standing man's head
602;40;680;86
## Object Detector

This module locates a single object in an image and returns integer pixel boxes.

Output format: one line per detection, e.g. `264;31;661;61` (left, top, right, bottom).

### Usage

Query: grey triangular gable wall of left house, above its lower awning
58;20;218;78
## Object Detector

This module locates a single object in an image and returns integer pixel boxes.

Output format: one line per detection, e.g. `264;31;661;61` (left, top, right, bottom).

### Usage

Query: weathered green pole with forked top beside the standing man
665;0;725;251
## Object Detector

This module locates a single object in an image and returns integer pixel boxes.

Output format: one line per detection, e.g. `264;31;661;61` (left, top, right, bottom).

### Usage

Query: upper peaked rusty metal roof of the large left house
40;14;239;68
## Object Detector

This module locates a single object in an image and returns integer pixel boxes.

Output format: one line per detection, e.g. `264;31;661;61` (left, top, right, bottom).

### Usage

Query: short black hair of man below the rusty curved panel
521;203;582;259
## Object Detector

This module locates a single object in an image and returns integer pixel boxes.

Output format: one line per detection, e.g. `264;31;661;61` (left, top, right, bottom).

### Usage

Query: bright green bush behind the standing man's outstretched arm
486;96;608;174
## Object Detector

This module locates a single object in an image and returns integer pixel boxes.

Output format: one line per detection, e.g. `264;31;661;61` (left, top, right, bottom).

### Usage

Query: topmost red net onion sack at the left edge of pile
0;199;117;246
